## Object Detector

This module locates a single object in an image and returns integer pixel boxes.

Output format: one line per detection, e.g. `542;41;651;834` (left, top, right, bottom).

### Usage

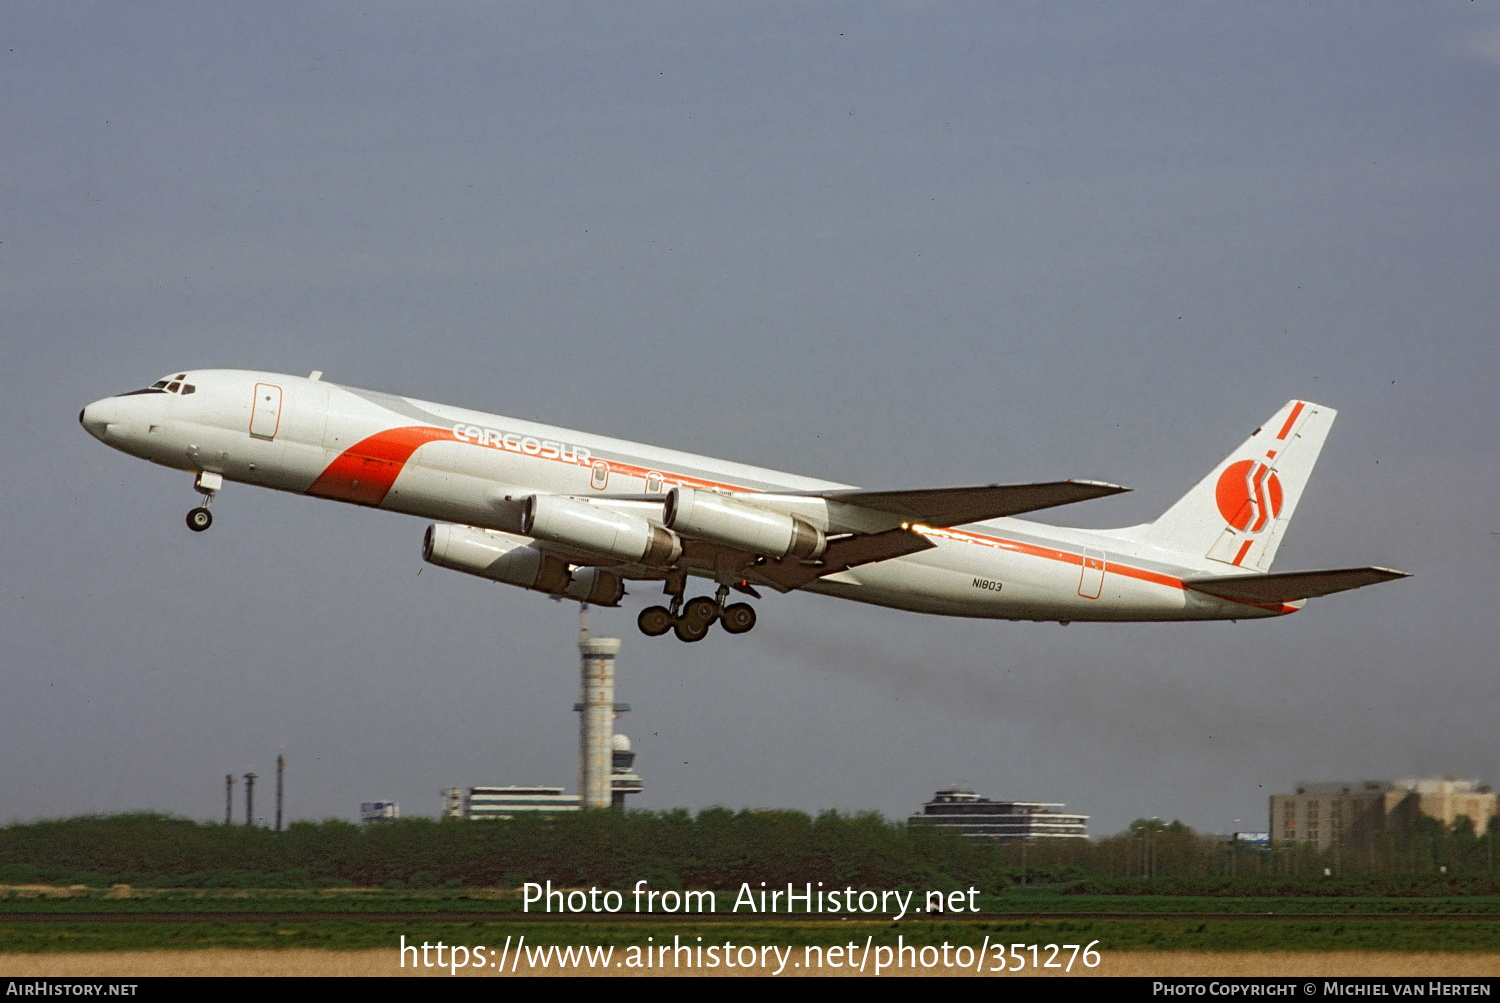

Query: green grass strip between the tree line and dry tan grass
0;886;1500;958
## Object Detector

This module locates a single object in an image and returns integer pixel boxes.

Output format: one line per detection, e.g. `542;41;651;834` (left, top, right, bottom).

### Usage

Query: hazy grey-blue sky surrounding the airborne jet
0;3;1500;835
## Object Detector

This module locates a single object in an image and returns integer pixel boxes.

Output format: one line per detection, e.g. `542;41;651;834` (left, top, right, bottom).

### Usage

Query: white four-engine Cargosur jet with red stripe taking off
78;369;1406;642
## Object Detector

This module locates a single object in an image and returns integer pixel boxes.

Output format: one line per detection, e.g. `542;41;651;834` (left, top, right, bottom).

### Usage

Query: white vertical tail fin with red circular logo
1130;400;1338;571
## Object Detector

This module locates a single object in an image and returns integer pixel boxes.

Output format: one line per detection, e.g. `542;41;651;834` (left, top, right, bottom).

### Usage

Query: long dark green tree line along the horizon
0;808;1500;895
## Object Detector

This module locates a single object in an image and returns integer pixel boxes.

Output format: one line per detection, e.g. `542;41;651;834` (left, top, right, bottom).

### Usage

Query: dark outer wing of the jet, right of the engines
821;481;1130;528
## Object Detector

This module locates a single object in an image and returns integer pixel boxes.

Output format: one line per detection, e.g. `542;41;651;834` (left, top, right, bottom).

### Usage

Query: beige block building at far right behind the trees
1271;778;1497;850
